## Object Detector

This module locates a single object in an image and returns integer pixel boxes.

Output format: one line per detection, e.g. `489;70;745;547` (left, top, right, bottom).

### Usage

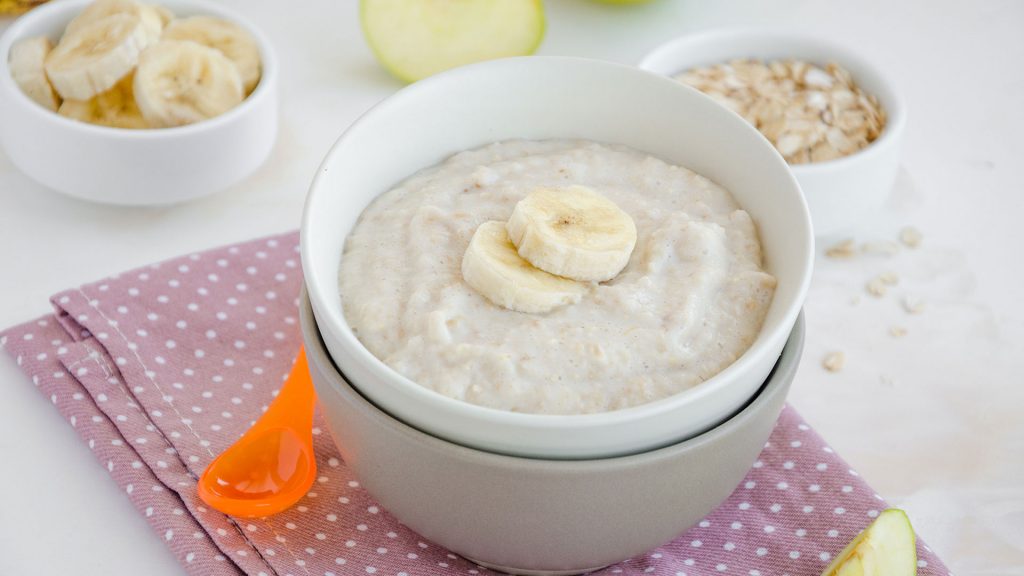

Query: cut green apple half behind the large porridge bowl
359;0;545;82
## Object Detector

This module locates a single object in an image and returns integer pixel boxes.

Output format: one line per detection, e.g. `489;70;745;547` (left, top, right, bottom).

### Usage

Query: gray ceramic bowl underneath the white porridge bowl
301;293;804;574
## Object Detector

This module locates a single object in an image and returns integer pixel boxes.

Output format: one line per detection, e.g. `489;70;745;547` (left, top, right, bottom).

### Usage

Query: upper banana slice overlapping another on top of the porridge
508;186;637;282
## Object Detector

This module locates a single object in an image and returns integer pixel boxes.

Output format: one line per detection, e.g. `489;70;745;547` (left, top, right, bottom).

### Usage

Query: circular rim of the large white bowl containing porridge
300;56;814;431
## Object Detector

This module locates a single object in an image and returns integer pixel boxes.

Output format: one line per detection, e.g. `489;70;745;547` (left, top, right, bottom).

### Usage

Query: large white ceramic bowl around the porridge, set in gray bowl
302;56;813;458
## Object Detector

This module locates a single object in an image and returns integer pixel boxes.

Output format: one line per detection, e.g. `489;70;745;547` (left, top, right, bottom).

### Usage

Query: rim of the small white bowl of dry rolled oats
637;27;906;174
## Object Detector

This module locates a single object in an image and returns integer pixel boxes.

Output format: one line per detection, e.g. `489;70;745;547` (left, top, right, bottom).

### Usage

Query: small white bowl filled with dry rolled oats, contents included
640;29;906;237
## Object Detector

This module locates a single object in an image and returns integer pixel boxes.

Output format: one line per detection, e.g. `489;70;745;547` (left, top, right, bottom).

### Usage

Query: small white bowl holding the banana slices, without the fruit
0;0;278;206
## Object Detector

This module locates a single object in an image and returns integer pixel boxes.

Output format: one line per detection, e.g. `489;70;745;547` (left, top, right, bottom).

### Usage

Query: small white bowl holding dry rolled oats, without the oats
640;29;906;237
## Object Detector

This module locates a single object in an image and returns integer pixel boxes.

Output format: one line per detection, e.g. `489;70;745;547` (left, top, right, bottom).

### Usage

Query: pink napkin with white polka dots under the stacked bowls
0;229;947;576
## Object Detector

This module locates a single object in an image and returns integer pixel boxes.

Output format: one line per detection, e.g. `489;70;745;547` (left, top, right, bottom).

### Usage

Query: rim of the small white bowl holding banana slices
0;0;278;140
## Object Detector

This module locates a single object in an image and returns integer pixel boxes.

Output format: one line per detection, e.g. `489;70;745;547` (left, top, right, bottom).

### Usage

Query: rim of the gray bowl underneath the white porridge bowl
299;284;807;472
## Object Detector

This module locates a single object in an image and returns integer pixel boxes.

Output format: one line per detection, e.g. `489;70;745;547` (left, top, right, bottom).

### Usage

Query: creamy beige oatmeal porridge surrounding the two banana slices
339;140;775;414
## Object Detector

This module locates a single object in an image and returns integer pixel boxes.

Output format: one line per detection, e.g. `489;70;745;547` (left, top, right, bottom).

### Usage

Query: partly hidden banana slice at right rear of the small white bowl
163;16;260;94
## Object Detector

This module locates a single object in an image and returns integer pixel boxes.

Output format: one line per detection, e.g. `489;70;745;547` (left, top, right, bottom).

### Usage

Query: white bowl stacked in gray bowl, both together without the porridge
302;57;813;574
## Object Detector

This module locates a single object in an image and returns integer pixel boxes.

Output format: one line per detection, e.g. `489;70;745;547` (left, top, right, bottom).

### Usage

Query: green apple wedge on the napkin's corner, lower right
821;508;918;576
